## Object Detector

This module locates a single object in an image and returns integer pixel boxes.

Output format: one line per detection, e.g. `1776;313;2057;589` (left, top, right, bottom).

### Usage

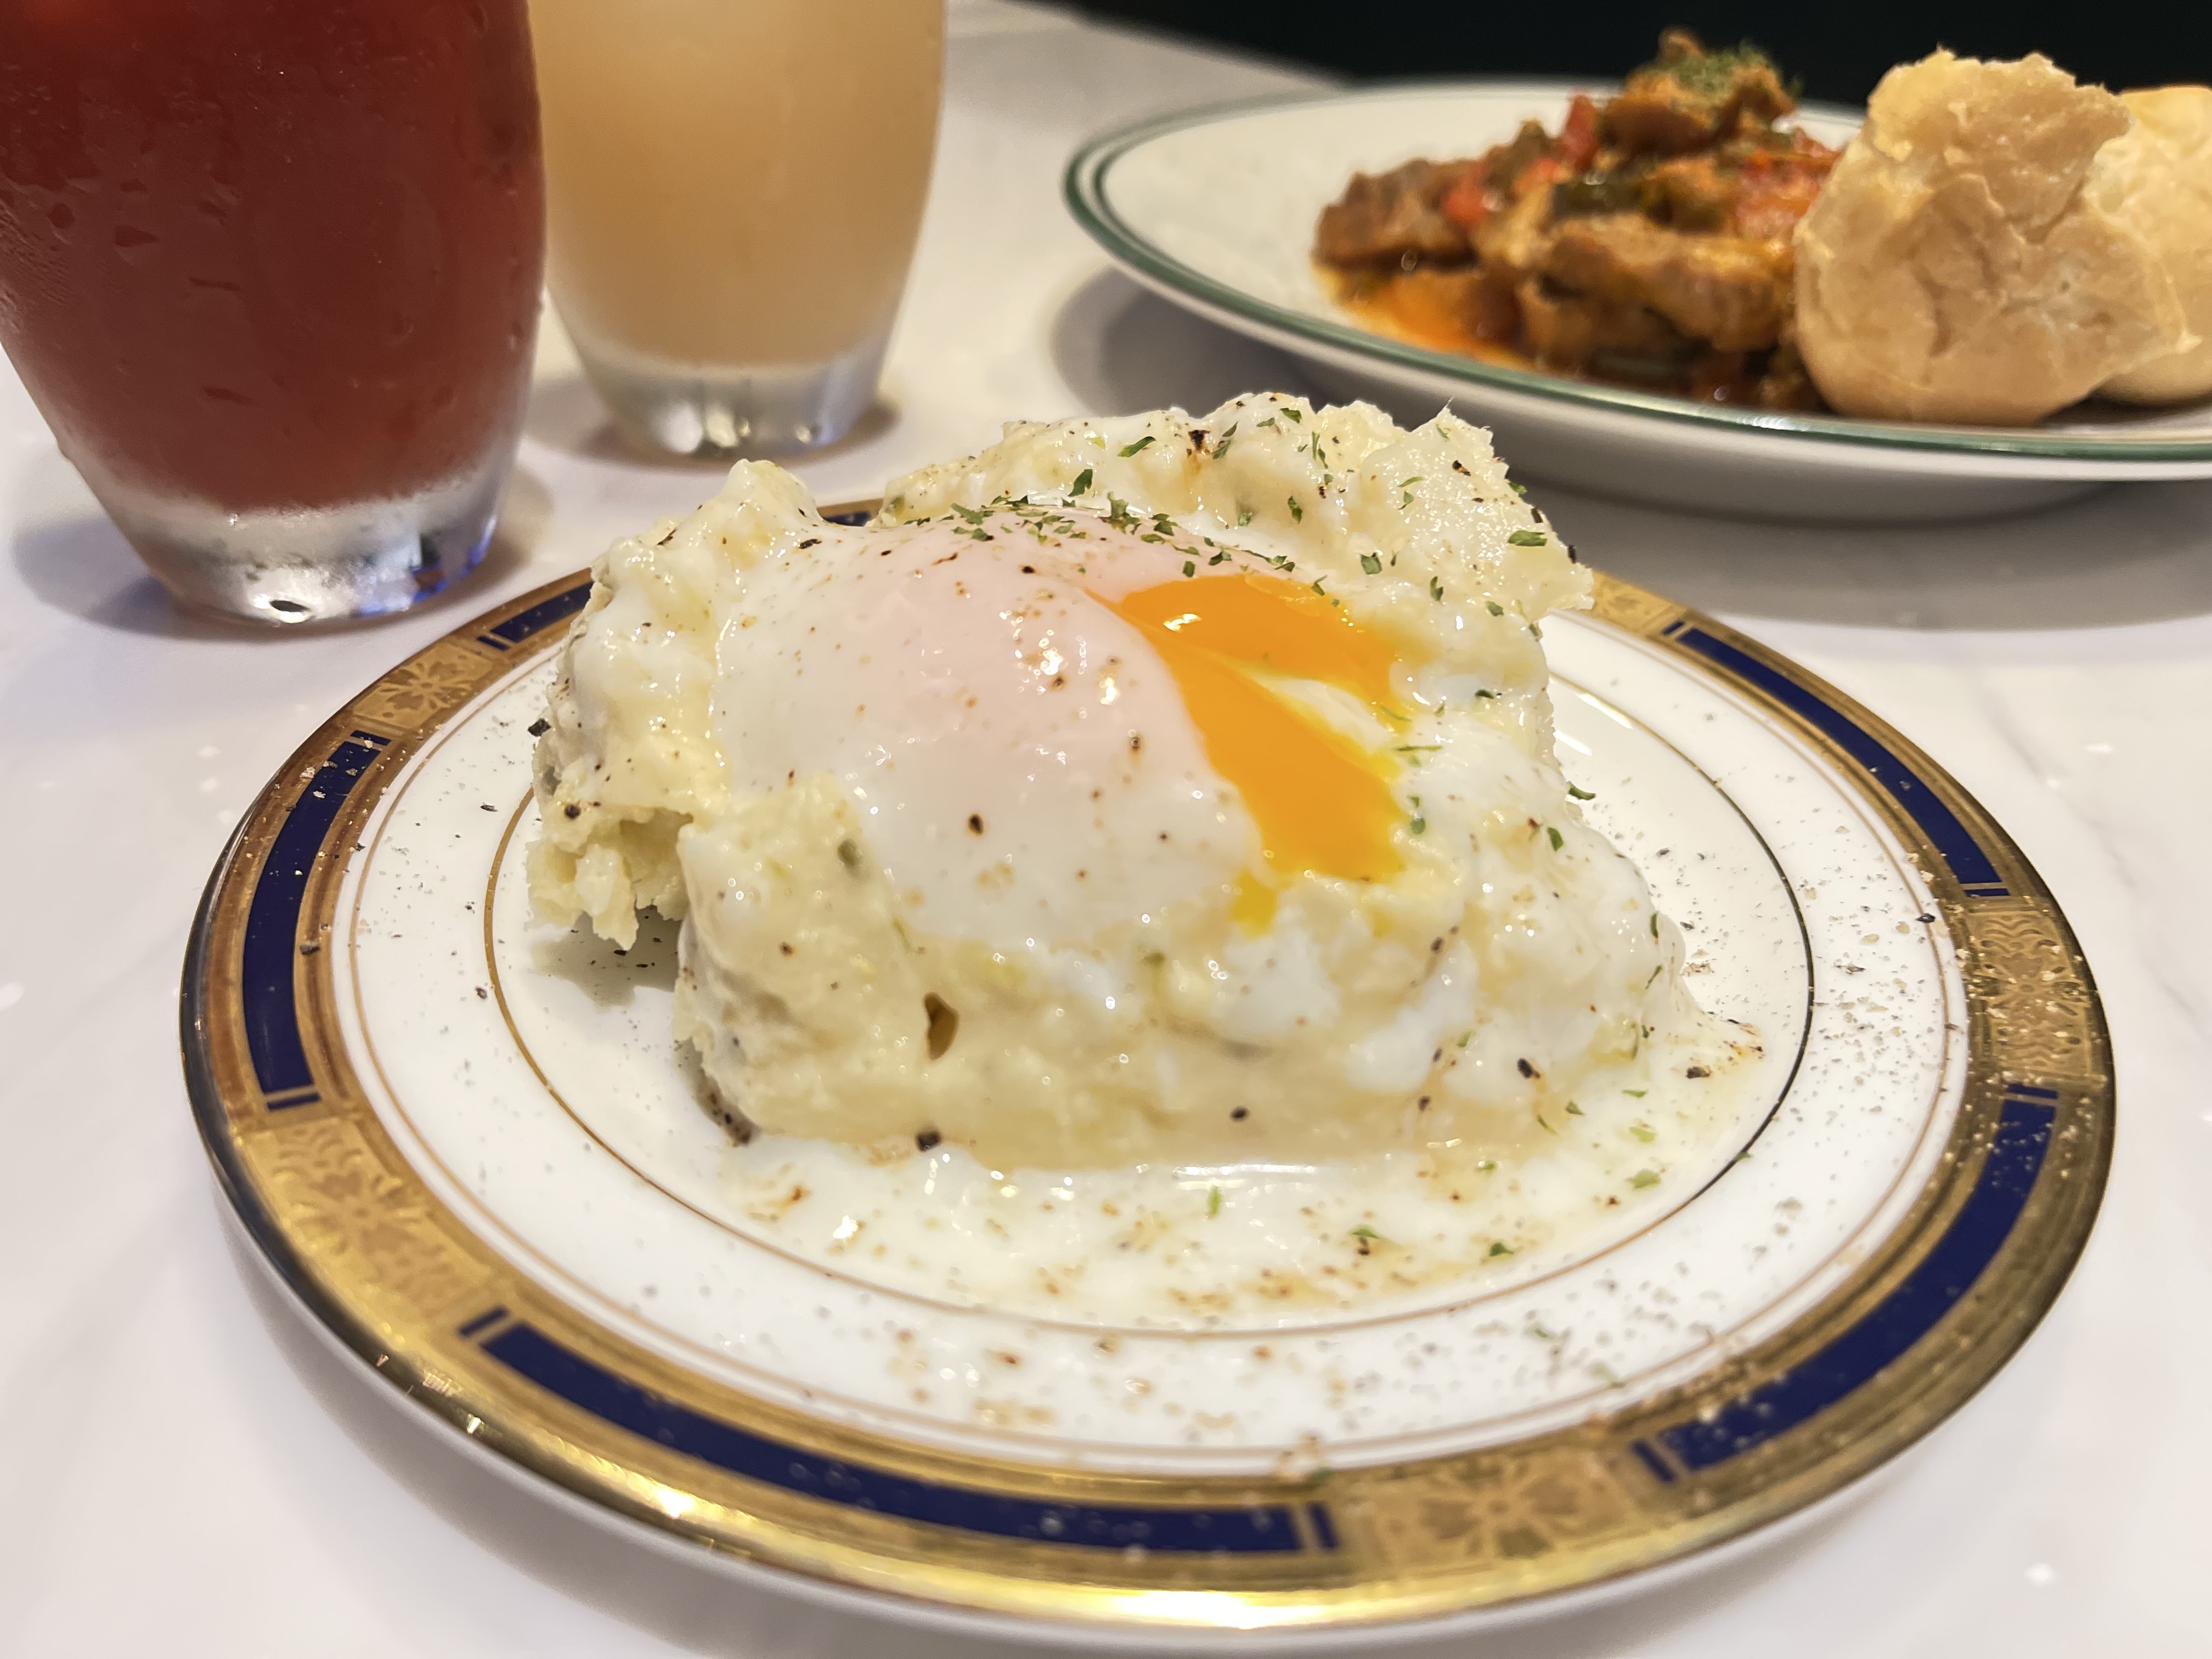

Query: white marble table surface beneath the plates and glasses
0;0;2212;1659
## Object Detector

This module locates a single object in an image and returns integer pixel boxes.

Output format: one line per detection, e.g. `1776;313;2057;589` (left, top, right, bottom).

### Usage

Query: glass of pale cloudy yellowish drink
531;0;945;458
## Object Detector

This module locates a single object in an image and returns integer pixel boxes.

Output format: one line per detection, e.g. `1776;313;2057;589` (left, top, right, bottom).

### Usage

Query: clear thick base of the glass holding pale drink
568;328;889;460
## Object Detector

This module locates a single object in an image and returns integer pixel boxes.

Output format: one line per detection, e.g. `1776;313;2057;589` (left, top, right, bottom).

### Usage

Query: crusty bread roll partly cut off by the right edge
2090;86;2212;403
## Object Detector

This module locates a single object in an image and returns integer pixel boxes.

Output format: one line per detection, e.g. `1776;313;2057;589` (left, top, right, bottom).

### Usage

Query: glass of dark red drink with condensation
0;0;544;622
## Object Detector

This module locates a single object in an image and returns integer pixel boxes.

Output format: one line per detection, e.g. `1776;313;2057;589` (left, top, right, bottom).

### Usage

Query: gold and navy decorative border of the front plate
184;541;2113;1630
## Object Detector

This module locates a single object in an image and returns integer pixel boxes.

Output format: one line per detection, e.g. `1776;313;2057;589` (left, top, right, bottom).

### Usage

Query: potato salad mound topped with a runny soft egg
531;396;1699;1168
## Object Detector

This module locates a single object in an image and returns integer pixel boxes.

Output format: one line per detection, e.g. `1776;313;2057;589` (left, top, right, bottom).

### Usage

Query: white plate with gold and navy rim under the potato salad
184;528;2113;1650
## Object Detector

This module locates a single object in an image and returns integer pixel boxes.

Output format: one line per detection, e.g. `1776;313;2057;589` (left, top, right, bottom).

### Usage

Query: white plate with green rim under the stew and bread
1066;82;2212;520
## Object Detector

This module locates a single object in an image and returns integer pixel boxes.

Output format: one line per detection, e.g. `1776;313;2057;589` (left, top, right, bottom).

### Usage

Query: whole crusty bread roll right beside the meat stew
1796;51;2188;425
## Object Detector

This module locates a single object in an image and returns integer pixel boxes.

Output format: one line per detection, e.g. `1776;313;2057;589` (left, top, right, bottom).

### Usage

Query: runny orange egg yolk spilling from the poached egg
1102;571;1404;927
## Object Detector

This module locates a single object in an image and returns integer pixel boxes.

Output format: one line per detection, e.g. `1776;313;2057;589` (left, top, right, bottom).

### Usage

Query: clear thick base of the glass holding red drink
84;442;513;626
